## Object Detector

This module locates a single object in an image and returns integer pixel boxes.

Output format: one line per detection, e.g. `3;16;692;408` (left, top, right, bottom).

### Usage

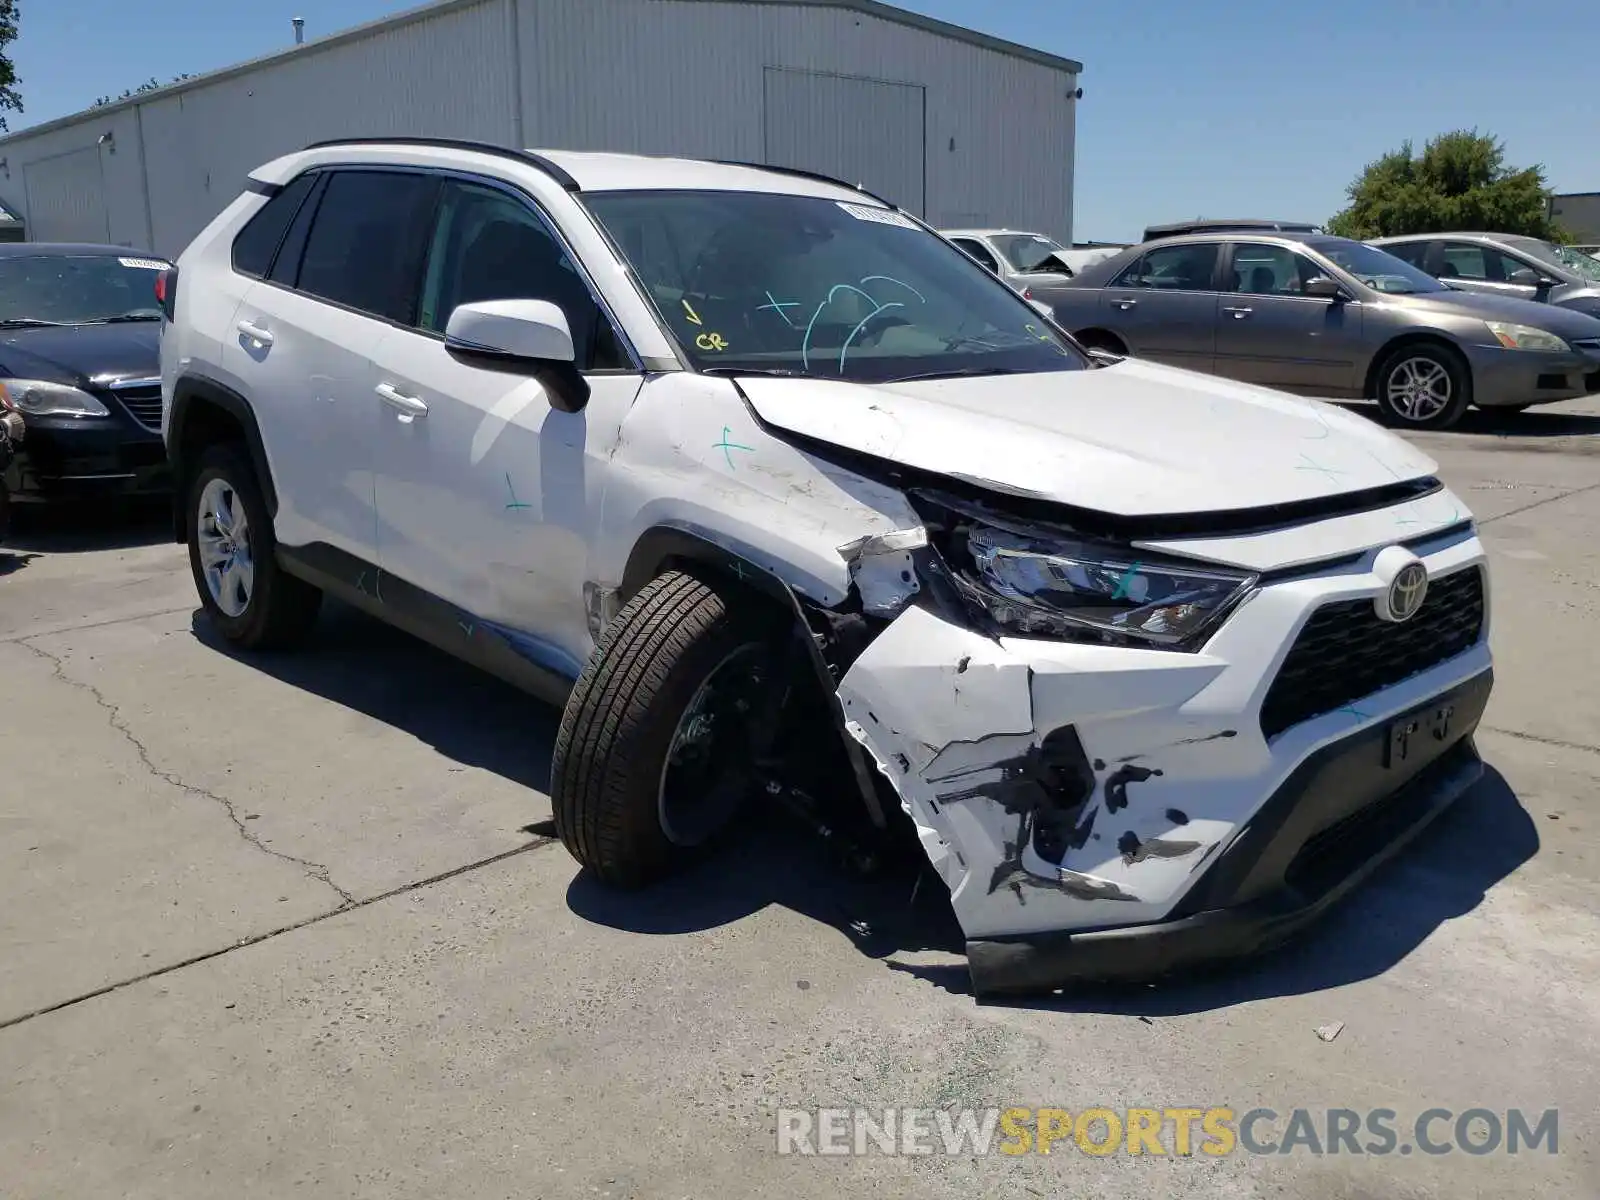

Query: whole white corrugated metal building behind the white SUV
0;0;1082;254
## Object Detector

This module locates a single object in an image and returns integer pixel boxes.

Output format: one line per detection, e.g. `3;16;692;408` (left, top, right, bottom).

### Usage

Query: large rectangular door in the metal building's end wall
762;67;928;216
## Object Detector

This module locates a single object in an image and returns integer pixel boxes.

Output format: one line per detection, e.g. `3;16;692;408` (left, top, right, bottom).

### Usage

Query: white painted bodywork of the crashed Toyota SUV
163;146;1490;966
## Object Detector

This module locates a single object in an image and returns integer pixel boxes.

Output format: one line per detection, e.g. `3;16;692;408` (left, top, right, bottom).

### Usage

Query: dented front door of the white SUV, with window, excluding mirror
371;179;643;675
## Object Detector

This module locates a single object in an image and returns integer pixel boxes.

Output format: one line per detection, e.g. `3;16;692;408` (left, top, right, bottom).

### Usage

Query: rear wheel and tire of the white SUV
189;445;322;650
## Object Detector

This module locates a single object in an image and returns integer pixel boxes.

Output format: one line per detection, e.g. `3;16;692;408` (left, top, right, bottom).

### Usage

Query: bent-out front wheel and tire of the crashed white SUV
550;571;779;890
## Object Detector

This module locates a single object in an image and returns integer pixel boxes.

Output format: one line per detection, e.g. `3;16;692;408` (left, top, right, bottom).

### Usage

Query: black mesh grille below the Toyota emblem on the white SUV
1261;566;1483;738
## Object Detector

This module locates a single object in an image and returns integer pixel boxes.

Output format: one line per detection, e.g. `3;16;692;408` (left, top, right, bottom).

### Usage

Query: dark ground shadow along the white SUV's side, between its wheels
192;600;560;794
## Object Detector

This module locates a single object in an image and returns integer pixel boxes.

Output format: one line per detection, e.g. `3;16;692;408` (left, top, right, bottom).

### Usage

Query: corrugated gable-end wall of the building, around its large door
518;0;1077;242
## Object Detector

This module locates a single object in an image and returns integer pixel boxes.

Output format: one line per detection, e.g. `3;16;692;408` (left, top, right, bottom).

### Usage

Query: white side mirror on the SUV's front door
445;299;589;413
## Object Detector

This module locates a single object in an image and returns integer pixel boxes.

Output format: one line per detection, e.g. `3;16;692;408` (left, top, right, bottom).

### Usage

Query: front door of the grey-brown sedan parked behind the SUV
1216;242;1363;397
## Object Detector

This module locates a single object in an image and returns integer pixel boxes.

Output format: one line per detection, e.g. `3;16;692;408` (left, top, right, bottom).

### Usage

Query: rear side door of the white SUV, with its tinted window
224;168;438;562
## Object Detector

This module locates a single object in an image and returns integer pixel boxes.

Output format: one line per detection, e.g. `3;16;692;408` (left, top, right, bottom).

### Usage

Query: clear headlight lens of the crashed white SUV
957;525;1256;646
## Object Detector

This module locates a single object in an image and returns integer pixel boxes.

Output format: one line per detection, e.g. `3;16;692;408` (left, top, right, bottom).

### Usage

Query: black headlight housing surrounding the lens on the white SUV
914;493;1261;653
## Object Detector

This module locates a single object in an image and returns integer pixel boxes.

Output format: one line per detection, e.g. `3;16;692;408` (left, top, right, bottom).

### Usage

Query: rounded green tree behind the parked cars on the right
1328;130;1565;240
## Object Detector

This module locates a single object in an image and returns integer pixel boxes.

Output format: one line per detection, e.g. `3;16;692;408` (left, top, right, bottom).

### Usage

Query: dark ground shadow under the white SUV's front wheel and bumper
566;768;1539;1018
